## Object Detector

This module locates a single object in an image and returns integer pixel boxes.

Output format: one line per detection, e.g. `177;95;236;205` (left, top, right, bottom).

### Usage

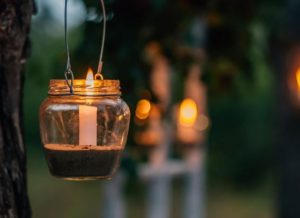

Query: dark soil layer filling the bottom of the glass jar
44;144;123;180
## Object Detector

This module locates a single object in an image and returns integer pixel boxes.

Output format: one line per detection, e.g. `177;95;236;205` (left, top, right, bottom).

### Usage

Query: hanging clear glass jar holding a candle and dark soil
40;80;130;180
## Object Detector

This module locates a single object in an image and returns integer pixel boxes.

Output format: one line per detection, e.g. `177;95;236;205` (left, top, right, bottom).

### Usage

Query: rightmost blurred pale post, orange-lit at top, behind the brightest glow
183;60;209;218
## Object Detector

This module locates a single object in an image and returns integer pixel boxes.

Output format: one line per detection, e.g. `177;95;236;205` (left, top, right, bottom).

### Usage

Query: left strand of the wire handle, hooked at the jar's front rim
64;0;74;95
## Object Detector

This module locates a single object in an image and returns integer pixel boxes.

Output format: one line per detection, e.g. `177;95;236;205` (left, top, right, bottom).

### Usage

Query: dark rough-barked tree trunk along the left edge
0;0;33;218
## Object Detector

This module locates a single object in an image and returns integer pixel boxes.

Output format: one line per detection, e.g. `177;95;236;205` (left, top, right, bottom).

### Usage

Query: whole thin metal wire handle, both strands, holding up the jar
64;0;107;95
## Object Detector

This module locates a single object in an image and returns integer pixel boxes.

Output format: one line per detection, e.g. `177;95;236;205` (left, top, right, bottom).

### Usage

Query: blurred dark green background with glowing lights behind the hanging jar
24;0;300;218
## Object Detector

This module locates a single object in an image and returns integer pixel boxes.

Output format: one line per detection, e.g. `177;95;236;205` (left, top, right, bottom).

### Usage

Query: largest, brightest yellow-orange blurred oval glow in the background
179;99;198;127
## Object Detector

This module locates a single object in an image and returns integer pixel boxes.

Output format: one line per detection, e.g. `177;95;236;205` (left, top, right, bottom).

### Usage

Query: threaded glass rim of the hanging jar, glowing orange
48;79;121;96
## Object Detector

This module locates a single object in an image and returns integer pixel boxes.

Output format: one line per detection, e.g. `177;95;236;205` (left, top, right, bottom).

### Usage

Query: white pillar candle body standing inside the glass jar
79;105;97;145
